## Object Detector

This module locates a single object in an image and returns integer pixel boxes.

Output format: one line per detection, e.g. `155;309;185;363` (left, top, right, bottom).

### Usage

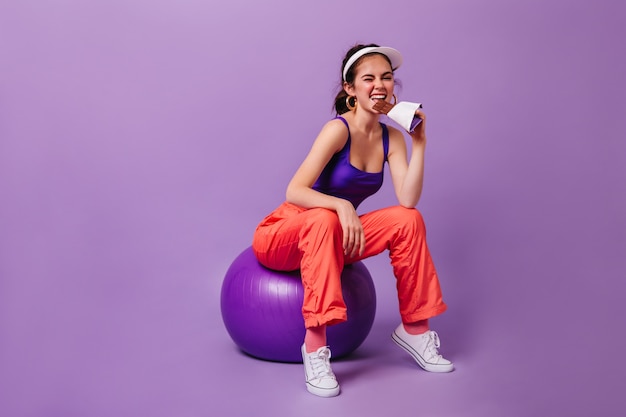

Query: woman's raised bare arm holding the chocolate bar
388;110;426;208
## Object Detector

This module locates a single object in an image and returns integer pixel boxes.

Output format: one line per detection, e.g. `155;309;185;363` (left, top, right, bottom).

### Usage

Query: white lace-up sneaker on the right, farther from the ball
391;324;454;372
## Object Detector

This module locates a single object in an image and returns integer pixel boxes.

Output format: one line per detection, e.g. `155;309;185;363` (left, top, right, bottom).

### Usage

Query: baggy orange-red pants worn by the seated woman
252;202;446;328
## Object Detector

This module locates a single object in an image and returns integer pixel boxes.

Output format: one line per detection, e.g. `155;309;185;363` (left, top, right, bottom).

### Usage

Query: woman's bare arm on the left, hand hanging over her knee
286;120;365;255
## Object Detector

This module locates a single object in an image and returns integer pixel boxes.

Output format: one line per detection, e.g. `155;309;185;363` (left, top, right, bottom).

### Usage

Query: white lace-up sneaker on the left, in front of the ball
302;345;339;397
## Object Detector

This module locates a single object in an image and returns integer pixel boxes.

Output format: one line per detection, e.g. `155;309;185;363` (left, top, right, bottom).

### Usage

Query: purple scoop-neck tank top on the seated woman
313;116;389;208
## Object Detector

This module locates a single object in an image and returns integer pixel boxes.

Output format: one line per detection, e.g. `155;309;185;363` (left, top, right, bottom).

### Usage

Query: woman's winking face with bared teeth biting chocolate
345;54;394;113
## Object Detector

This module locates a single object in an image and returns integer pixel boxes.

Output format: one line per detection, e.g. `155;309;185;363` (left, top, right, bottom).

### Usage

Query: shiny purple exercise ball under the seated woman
221;247;376;362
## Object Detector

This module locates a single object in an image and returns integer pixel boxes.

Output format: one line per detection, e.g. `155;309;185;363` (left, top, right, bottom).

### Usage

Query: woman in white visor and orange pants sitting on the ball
252;44;453;397
